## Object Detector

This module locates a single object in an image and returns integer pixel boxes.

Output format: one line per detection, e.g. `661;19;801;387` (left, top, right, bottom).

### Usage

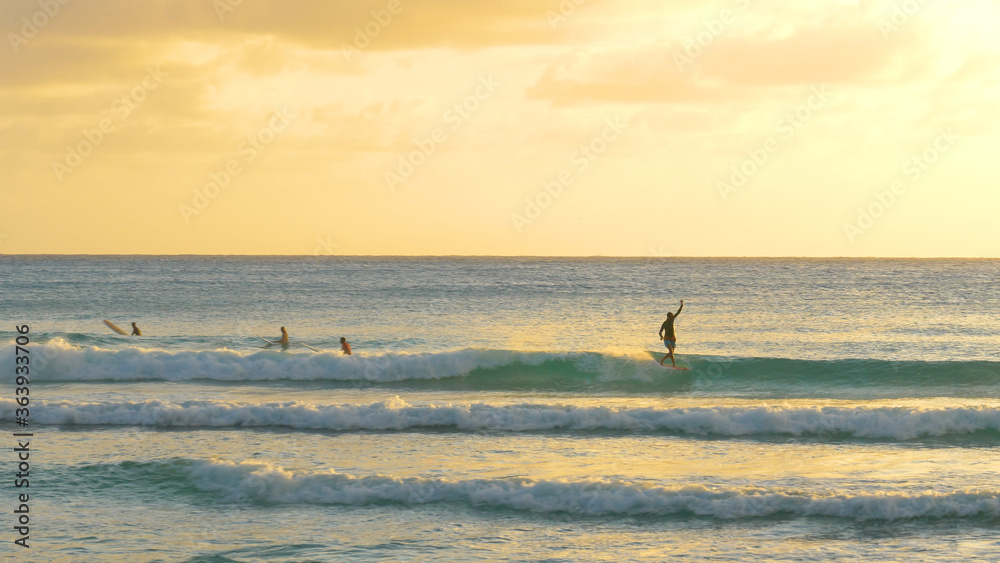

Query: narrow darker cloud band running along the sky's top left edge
0;0;588;50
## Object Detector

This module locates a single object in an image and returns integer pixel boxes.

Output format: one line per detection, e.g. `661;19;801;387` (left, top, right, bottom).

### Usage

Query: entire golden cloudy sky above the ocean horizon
0;0;1000;257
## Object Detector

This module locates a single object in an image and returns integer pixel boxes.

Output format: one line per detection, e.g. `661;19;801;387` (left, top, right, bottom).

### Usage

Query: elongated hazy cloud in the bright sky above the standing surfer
528;21;920;105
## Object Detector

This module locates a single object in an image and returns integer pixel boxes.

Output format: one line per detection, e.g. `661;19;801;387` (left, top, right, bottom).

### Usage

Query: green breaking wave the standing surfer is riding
9;339;1000;397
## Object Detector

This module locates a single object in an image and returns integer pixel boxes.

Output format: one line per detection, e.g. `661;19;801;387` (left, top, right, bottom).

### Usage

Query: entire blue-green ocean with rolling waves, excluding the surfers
0;256;1000;562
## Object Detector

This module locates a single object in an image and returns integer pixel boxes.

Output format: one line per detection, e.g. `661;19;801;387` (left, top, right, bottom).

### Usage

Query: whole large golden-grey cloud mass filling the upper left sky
0;0;602;112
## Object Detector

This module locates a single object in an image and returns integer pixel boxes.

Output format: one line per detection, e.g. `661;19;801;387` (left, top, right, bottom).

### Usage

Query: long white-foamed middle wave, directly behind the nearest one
11;398;1000;441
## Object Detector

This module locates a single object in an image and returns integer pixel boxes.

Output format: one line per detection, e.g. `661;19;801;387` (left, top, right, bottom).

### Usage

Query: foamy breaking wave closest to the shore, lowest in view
76;459;1000;521
